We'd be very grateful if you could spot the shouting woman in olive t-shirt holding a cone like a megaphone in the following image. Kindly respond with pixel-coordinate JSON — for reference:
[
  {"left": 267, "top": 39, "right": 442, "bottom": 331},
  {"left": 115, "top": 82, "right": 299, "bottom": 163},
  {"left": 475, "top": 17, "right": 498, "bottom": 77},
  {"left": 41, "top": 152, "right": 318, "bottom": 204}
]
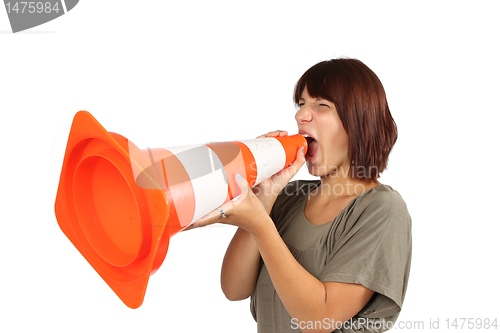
[{"left": 191, "top": 59, "right": 411, "bottom": 332}]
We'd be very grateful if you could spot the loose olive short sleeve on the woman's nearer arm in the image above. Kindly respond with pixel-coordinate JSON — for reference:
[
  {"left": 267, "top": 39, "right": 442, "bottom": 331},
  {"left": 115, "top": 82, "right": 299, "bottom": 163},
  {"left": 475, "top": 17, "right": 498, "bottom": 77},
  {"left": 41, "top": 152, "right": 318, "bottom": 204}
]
[{"left": 320, "top": 186, "right": 411, "bottom": 317}]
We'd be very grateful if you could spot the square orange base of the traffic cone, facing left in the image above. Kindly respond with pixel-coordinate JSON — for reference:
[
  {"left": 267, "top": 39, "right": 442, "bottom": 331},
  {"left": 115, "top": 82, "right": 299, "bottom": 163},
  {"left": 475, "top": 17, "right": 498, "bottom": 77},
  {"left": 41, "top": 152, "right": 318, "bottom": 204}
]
[{"left": 55, "top": 111, "right": 169, "bottom": 308}]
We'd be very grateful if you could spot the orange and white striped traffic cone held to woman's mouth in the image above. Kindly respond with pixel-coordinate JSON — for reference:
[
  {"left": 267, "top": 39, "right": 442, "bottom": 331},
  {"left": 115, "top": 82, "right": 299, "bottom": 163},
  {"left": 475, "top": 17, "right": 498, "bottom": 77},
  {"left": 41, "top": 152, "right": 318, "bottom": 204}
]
[{"left": 55, "top": 111, "right": 307, "bottom": 308}]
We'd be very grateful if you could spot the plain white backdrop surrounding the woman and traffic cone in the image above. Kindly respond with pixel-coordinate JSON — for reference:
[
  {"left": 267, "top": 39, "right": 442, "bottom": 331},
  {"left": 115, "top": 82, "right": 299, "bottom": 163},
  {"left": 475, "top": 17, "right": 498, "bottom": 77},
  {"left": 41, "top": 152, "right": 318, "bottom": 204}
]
[{"left": 0, "top": 0, "right": 500, "bottom": 332}]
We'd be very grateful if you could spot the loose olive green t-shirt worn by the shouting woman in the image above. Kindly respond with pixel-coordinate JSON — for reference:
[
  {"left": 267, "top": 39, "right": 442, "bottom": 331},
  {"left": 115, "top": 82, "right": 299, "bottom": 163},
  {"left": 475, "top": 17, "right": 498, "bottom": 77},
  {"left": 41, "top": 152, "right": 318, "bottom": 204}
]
[{"left": 250, "top": 181, "right": 412, "bottom": 333}]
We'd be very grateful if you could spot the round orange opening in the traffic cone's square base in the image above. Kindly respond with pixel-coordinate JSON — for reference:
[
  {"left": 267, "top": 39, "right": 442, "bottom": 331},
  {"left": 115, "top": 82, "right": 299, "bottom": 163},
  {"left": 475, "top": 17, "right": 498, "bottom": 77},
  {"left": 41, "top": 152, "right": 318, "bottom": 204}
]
[{"left": 72, "top": 155, "right": 143, "bottom": 267}]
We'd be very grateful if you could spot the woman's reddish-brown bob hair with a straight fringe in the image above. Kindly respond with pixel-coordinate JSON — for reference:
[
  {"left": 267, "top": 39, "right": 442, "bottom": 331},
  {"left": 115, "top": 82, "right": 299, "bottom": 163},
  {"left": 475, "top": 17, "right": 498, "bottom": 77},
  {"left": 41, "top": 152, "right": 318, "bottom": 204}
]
[{"left": 294, "top": 58, "right": 398, "bottom": 180}]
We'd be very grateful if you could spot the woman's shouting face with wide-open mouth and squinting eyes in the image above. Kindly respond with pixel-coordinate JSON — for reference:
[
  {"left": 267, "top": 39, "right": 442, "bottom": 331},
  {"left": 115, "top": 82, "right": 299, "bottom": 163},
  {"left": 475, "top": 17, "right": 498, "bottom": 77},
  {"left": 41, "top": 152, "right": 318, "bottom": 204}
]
[{"left": 295, "top": 88, "right": 349, "bottom": 177}]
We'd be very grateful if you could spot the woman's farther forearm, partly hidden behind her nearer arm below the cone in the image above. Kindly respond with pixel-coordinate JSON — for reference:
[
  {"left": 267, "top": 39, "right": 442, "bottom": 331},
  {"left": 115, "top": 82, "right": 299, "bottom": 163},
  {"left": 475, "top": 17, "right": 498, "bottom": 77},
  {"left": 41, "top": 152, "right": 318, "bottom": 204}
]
[{"left": 221, "top": 228, "right": 260, "bottom": 300}]
